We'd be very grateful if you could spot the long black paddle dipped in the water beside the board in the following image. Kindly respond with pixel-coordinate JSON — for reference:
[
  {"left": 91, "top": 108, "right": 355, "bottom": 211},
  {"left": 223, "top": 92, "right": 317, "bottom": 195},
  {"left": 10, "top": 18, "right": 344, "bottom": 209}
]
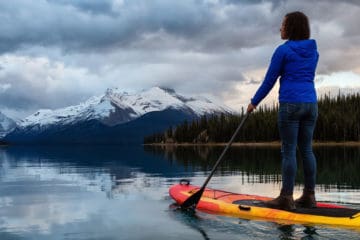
[{"left": 180, "top": 112, "right": 250, "bottom": 209}]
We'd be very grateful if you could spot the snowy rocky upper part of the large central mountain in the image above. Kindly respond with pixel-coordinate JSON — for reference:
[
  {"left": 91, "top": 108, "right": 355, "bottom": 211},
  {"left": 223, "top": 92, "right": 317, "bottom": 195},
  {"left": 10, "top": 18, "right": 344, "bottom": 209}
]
[{"left": 20, "top": 87, "right": 232, "bottom": 127}]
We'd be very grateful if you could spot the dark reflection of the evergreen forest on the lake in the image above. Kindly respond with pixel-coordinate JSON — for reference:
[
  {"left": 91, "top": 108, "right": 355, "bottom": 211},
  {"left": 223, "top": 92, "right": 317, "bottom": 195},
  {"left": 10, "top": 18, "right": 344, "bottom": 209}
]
[{"left": 145, "top": 146, "right": 360, "bottom": 190}]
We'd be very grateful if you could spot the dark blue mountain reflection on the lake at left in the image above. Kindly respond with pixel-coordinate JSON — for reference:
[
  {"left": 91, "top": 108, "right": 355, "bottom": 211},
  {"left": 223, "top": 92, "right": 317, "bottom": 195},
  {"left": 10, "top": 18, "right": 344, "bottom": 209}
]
[{"left": 0, "top": 146, "right": 191, "bottom": 179}]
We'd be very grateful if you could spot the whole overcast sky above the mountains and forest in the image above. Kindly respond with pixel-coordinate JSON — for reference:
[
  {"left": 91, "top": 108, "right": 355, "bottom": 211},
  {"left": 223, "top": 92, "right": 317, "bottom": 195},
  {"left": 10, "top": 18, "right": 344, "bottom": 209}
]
[{"left": 0, "top": 0, "right": 360, "bottom": 118}]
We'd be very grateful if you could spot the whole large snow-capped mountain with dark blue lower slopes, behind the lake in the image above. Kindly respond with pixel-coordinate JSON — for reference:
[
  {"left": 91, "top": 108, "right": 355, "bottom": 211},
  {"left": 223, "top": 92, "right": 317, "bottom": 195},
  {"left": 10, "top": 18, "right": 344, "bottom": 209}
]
[{"left": 4, "top": 87, "right": 233, "bottom": 143}]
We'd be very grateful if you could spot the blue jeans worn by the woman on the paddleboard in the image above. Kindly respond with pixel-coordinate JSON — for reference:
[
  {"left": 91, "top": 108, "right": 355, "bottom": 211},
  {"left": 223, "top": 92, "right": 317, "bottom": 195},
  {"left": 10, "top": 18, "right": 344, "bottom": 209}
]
[{"left": 278, "top": 103, "right": 318, "bottom": 195}]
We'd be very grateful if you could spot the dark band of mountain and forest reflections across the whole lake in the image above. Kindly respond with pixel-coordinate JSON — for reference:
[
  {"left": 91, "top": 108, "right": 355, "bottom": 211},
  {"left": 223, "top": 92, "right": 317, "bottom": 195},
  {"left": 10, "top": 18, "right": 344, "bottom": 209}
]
[{"left": 0, "top": 146, "right": 360, "bottom": 190}]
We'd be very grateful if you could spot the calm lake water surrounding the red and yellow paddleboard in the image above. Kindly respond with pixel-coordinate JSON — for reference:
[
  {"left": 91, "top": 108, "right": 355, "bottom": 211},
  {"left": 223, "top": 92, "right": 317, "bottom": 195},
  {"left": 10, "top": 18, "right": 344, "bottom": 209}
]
[{"left": 0, "top": 146, "right": 360, "bottom": 240}]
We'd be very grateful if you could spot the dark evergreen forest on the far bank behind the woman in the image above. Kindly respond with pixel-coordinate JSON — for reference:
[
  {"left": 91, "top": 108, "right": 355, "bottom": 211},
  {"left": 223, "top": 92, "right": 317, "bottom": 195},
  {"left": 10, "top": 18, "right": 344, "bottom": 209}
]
[{"left": 144, "top": 93, "right": 360, "bottom": 143}]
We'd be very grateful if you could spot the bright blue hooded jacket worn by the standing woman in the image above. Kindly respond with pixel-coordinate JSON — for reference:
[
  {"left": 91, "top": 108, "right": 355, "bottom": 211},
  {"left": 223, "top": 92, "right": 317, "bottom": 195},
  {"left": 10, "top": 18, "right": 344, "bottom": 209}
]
[{"left": 251, "top": 39, "right": 319, "bottom": 106}]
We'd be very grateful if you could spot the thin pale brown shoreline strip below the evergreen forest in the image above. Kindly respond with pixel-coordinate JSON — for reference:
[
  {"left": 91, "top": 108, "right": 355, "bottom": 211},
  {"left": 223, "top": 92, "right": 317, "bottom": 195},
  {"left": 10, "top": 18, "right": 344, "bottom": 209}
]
[{"left": 143, "top": 141, "right": 360, "bottom": 147}]
